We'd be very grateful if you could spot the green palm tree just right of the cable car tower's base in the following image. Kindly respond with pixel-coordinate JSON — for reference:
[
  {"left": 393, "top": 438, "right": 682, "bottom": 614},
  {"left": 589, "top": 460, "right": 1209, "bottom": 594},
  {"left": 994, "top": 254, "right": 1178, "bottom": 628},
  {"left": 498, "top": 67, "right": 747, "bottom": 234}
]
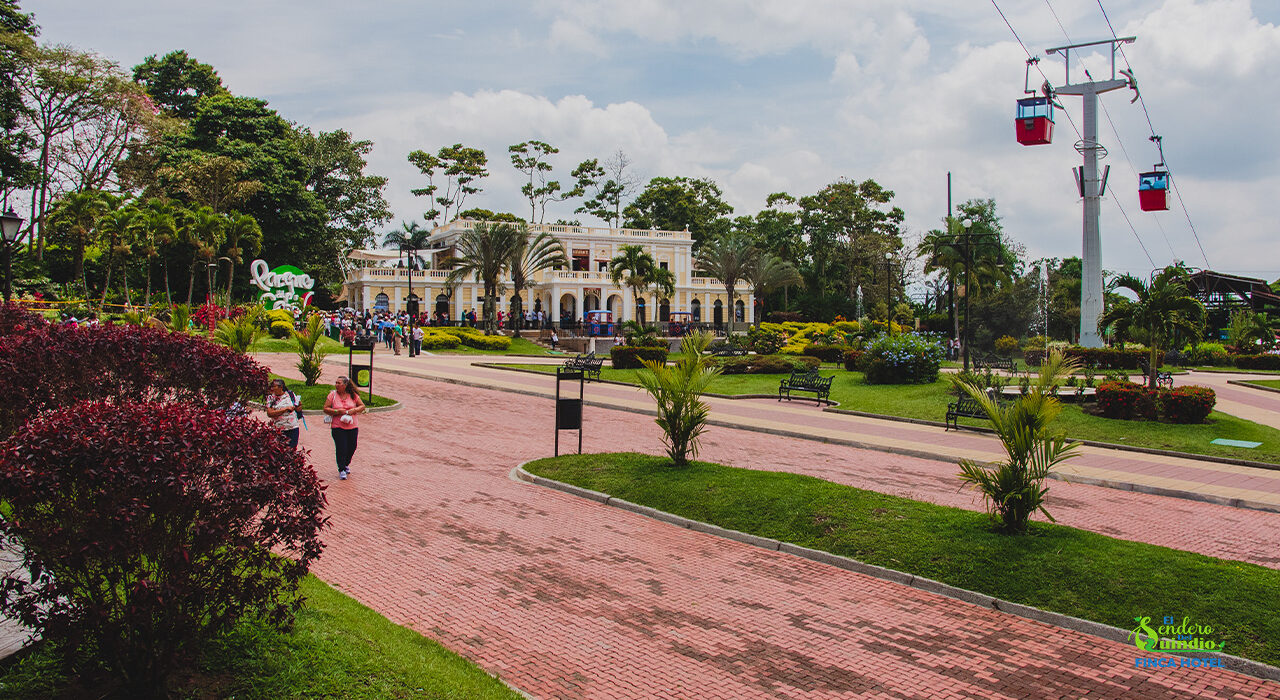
[{"left": 1098, "top": 265, "right": 1204, "bottom": 389}]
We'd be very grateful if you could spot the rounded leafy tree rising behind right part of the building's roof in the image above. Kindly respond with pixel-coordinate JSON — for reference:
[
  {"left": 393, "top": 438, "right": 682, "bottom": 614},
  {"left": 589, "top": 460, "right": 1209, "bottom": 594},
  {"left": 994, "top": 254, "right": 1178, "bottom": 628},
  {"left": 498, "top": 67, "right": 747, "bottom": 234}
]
[{"left": 622, "top": 178, "right": 733, "bottom": 244}]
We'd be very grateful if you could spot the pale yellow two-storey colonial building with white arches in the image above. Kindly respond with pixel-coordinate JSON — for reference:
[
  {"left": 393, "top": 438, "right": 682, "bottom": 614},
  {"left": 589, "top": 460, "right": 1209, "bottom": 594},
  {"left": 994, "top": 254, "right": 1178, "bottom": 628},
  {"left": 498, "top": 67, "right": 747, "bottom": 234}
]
[{"left": 344, "top": 219, "right": 755, "bottom": 325}]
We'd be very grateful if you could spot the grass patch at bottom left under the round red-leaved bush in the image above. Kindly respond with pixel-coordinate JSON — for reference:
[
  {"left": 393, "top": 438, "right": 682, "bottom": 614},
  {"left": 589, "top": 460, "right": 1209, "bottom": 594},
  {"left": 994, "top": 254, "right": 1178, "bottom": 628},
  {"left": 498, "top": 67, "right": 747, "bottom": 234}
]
[{"left": 0, "top": 577, "right": 520, "bottom": 700}]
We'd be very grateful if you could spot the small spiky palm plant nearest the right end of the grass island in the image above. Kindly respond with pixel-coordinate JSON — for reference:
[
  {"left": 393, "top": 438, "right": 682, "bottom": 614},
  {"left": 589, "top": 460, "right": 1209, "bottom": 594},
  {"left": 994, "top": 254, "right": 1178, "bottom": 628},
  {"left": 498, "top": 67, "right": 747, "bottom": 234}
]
[{"left": 954, "top": 351, "right": 1079, "bottom": 534}]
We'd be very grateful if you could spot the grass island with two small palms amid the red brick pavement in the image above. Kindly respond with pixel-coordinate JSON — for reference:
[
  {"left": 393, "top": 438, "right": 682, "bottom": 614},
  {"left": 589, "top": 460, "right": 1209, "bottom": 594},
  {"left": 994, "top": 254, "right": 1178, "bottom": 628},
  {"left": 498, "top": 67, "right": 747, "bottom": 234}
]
[{"left": 525, "top": 453, "right": 1280, "bottom": 664}]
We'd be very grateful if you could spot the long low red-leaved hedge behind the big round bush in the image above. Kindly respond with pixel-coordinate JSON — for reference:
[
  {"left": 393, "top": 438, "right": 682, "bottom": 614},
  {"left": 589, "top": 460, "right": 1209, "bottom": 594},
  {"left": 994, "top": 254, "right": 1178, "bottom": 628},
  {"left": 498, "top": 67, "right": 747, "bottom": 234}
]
[{"left": 0, "top": 324, "right": 268, "bottom": 438}]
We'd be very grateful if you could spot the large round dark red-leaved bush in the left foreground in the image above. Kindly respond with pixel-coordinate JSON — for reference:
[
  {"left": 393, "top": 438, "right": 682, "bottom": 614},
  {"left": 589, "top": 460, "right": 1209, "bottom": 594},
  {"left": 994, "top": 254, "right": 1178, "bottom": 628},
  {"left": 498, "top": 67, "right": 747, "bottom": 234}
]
[{"left": 0, "top": 402, "right": 326, "bottom": 696}]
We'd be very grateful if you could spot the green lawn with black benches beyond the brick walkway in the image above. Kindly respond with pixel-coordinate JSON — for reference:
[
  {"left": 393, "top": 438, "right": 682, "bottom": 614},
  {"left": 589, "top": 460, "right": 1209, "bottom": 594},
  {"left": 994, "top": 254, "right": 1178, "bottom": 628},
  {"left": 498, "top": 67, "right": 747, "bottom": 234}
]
[{"left": 501, "top": 365, "right": 1280, "bottom": 463}]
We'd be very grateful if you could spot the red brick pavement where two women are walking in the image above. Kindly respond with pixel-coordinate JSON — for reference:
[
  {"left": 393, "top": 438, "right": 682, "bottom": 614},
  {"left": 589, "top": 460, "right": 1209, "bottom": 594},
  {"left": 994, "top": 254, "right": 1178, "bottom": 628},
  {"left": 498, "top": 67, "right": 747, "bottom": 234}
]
[{"left": 275, "top": 363, "right": 1280, "bottom": 699}]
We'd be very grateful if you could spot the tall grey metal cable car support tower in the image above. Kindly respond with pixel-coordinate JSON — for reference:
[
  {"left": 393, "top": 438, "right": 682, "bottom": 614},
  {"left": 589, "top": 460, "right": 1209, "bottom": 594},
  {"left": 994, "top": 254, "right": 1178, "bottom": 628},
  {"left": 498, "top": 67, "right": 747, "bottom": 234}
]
[{"left": 1044, "top": 36, "right": 1138, "bottom": 348}]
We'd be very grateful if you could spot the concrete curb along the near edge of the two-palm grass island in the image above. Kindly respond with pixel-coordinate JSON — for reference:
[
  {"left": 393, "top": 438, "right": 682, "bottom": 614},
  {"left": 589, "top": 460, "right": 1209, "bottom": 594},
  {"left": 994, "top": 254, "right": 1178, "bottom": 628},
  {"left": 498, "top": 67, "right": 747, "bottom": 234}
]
[{"left": 511, "top": 462, "right": 1280, "bottom": 682}]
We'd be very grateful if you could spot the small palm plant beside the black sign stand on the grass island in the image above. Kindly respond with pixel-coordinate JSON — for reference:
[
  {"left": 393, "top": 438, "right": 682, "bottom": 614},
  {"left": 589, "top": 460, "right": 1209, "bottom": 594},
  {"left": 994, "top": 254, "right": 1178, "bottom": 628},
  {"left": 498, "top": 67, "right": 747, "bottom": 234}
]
[{"left": 636, "top": 331, "right": 721, "bottom": 467}]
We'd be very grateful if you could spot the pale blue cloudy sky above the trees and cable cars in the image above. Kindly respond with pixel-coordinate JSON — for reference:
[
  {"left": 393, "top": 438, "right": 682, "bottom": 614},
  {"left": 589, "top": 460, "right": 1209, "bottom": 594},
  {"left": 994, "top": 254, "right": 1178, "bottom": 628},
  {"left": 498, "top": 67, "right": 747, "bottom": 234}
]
[{"left": 22, "top": 0, "right": 1280, "bottom": 280}]
